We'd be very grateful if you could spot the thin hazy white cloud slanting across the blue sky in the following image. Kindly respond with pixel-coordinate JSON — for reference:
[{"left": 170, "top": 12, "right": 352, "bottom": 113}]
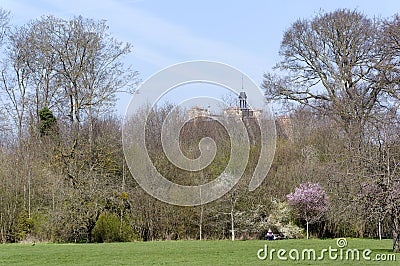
[{"left": 18, "top": 0, "right": 265, "bottom": 80}]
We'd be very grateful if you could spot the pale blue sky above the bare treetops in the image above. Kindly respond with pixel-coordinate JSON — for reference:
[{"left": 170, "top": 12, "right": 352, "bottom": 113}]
[{"left": 0, "top": 0, "right": 400, "bottom": 114}]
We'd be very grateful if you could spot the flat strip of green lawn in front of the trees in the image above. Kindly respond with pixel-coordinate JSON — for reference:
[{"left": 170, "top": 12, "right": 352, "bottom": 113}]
[{"left": 0, "top": 239, "right": 400, "bottom": 265}]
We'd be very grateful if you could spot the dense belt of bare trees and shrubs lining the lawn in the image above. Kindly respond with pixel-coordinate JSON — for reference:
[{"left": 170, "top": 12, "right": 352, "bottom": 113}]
[{"left": 0, "top": 10, "right": 400, "bottom": 250}]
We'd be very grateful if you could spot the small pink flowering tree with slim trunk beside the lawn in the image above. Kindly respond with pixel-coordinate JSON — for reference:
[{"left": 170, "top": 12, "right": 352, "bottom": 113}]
[{"left": 286, "top": 183, "right": 328, "bottom": 239}]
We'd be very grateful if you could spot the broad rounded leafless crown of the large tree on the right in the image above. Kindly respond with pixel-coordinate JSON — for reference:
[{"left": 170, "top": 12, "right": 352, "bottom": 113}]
[{"left": 263, "top": 9, "right": 385, "bottom": 140}]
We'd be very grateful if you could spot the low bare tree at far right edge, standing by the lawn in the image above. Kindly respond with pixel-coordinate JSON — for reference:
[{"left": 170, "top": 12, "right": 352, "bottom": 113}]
[{"left": 359, "top": 112, "right": 400, "bottom": 252}]
